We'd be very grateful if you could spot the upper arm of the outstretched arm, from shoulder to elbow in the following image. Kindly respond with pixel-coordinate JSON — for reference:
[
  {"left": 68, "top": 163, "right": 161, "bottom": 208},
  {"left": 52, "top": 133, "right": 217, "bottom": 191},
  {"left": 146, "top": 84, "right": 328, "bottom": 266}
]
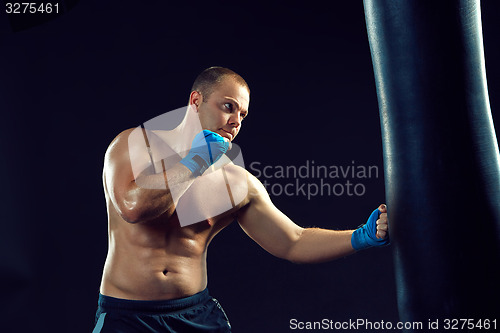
[{"left": 238, "top": 176, "right": 304, "bottom": 259}]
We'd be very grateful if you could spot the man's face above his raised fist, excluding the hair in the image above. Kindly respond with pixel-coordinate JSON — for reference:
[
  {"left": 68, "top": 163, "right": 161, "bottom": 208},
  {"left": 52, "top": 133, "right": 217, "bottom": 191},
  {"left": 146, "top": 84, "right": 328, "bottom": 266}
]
[{"left": 198, "top": 78, "right": 250, "bottom": 141}]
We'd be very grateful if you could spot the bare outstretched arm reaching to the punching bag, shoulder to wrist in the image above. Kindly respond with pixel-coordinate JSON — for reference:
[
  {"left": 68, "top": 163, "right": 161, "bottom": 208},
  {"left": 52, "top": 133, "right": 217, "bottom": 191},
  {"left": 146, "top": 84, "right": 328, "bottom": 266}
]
[{"left": 238, "top": 175, "right": 355, "bottom": 263}]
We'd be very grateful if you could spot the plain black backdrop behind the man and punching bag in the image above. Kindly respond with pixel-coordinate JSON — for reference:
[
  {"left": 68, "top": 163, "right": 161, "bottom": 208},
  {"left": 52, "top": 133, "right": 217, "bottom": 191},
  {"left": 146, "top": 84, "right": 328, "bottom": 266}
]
[{"left": 0, "top": 0, "right": 500, "bottom": 333}]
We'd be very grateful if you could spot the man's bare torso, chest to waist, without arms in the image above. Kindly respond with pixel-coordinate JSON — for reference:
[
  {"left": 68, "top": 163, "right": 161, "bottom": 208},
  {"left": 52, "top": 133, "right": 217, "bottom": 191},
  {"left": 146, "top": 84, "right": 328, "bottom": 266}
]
[{"left": 100, "top": 130, "right": 248, "bottom": 300}]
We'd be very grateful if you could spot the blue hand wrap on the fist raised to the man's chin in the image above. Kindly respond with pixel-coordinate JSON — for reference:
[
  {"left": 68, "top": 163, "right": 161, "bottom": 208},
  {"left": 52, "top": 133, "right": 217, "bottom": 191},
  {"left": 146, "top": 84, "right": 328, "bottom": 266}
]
[{"left": 180, "top": 130, "right": 229, "bottom": 176}]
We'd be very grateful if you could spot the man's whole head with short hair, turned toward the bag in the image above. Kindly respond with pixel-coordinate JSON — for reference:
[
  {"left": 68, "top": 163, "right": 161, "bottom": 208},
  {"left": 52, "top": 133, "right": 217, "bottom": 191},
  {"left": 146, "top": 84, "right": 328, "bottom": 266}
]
[{"left": 189, "top": 67, "right": 250, "bottom": 141}]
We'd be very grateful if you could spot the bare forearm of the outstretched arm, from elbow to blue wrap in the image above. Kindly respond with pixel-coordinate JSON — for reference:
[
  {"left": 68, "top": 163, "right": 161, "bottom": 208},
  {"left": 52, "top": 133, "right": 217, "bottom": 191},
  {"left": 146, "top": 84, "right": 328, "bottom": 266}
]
[{"left": 287, "top": 228, "right": 356, "bottom": 263}]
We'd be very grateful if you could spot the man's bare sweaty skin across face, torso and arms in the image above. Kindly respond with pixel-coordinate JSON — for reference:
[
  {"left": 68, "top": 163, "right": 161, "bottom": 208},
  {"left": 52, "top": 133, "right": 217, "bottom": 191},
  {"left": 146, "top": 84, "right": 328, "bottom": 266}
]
[{"left": 100, "top": 78, "right": 387, "bottom": 300}]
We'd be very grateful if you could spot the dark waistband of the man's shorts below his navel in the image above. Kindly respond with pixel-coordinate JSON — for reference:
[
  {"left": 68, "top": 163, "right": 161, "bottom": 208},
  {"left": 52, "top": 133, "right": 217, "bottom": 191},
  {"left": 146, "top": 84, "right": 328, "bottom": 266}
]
[{"left": 98, "top": 289, "right": 211, "bottom": 313}]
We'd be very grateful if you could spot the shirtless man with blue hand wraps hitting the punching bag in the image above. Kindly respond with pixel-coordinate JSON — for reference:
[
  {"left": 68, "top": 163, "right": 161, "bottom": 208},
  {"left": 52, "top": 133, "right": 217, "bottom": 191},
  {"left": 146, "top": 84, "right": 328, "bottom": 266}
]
[{"left": 94, "top": 67, "right": 388, "bottom": 333}]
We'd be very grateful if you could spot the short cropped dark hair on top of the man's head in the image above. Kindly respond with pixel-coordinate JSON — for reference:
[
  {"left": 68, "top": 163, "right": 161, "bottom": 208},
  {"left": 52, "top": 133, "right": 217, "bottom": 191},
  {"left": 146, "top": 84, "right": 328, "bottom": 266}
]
[{"left": 191, "top": 66, "right": 250, "bottom": 99}]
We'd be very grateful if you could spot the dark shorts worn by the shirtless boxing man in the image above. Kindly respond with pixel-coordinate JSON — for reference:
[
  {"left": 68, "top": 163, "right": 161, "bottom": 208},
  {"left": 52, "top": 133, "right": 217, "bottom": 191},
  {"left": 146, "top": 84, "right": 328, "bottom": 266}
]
[{"left": 92, "top": 289, "right": 231, "bottom": 333}]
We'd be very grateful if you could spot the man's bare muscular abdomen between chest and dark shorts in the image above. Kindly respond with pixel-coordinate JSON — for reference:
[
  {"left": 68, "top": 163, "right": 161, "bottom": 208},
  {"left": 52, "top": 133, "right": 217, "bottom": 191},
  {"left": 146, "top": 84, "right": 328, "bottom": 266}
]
[{"left": 100, "top": 202, "right": 232, "bottom": 300}]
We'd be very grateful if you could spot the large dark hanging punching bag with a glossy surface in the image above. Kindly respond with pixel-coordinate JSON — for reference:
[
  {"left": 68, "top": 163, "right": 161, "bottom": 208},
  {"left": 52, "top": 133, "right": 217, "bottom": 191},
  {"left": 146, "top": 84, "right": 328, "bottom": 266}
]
[{"left": 364, "top": 0, "right": 500, "bottom": 326}]
